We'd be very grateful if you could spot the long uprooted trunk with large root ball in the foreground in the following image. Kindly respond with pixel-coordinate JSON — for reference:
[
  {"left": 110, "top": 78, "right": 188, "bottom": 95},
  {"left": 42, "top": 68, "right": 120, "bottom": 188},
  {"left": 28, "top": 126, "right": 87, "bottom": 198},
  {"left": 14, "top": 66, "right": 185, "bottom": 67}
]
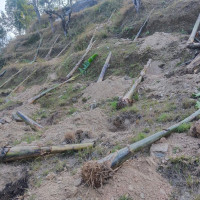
[{"left": 82, "top": 109, "right": 200, "bottom": 187}]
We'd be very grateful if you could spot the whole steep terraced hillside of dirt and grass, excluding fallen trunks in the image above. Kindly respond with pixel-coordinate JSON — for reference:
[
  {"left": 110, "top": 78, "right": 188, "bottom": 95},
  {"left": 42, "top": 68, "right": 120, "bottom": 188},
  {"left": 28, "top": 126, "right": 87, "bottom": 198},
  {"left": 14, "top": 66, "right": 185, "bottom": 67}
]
[{"left": 0, "top": 0, "right": 200, "bottom": 200}]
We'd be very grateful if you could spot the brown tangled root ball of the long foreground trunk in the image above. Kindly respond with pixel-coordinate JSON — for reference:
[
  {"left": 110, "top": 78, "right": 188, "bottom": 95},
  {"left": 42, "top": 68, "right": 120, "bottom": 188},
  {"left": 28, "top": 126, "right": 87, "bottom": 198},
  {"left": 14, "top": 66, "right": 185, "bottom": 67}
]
[{"left": 81, "top": 161, "right": 114, "bottom": 188}]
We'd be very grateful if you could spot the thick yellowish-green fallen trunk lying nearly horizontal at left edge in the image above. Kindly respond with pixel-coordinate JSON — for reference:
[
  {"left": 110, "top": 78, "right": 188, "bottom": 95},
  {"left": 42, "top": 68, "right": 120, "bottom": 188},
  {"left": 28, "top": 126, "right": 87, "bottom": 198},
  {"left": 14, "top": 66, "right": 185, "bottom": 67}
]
[{"left": 0, "top": 143, "right": 94, "bottom": 162}]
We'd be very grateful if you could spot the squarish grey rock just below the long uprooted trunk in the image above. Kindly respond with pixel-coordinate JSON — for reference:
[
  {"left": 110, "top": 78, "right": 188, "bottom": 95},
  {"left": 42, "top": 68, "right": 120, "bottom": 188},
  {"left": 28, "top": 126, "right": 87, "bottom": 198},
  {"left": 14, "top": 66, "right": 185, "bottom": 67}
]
[{"left": 150, "top": 143, "right": 169, "bottom": 158}]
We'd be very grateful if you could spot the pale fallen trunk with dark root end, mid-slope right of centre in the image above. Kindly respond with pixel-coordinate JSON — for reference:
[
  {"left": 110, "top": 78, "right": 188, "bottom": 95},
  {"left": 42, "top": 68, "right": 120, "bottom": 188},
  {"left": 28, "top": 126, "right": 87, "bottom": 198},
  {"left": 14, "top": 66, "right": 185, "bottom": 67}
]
[{"left": 117, "top": 59, "right": 152, "bottom": 109}]
